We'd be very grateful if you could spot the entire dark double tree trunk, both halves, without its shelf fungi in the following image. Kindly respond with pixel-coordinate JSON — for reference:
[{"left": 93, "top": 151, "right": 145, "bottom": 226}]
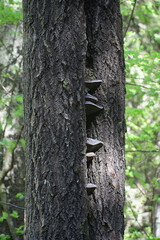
[{"left": 23, "top": 0, "right": 125, "bottom": 240}]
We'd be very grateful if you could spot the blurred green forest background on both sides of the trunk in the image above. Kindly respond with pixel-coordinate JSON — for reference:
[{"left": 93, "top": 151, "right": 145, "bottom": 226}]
[{"left": 0, "top": 0, "right": 160, "bottom": 240}]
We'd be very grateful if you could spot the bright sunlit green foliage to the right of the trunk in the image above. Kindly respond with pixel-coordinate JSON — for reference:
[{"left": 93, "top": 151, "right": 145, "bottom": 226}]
[{"left": 121, "top": 0, "right": 160, "bottom": 240}]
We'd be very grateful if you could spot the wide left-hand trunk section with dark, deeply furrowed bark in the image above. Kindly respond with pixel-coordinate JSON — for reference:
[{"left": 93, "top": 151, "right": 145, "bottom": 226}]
[{"left": 23, "top": 0, "right": 87, "bottom": 240}]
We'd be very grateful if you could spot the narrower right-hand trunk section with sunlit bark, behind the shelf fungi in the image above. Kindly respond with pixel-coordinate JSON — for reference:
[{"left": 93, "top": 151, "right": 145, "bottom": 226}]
[{"left": 85, "top": 0, "right": 125, "bottom": 240}]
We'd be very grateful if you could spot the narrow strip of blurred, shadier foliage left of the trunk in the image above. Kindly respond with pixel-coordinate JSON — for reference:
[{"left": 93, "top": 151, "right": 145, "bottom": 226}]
[{"left": 0, "top": 0, "right": 25, "bottom": 240}]
